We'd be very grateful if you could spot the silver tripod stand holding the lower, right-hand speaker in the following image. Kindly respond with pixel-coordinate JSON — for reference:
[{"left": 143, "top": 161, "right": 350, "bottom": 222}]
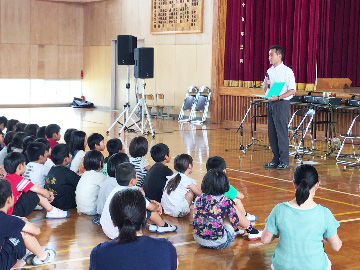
[{"left": 119, "top": 79, "right": 155, "bottom": 138}]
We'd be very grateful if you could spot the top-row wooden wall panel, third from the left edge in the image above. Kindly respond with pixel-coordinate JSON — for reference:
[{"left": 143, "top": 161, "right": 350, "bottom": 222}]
[{"left": 58, "top": 3, "right": 84, "bottom": 46}]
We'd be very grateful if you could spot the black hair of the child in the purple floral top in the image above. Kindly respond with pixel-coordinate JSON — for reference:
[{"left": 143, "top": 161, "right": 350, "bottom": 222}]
[{"left": 201, "top": 170, "right": 230, "bottom": 195}]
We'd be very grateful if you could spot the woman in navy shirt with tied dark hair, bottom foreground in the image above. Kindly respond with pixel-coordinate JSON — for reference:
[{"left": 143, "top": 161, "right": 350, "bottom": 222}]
[{"left": 90, "top": 189, "right": 177, "bottom": 270}]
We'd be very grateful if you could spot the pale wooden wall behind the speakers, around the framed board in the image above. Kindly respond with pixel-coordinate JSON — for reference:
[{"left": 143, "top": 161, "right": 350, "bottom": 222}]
[{"left": 84, "top": 0, "right": 213, "bottom": 113}]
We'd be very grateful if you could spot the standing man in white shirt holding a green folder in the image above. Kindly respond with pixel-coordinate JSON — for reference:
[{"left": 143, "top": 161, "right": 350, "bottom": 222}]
[{"left": 263, "top": 45, "right": 296, "bottom": 170}]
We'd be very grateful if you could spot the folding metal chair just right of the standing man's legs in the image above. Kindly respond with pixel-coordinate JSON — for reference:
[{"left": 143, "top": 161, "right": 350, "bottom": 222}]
[{"left": 288, "top": 108, "right": 315, "bottom": 163}]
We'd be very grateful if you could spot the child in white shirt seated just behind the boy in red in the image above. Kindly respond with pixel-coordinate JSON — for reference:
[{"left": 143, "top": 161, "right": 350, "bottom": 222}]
[{"left": 24, "top": 142, "right": 50, "bottom": 188}]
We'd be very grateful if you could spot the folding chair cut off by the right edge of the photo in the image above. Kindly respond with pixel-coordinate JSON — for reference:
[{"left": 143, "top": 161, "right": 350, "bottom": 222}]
[{"left": 336, "top": 115, "right": 360, "bottom": 169}]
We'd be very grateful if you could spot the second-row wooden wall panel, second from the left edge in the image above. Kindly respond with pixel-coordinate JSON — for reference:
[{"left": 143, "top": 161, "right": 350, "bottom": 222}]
[{"left": 30, "top": 45, "right": 59, "bottom": 79}]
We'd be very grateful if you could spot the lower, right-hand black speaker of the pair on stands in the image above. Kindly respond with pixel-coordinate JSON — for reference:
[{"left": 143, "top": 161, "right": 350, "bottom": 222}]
[{"left": 134, "top": 48, "right": 154, "bottom": 79}]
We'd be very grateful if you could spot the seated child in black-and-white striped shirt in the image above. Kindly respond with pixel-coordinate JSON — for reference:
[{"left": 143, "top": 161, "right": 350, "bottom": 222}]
[{"left": 129, "top": 137, "right": 151, "bottom": 187}]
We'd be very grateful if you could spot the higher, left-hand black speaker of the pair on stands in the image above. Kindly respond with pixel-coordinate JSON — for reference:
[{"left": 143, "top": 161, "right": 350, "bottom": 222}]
[{"left": 117, "top": 35, "right": 137, "bottom": 65}]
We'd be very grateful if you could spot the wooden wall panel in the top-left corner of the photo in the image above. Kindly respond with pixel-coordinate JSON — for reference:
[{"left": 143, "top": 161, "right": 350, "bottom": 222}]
[{"left": 0, "top": 0, "right": 30, "bottom": 44}]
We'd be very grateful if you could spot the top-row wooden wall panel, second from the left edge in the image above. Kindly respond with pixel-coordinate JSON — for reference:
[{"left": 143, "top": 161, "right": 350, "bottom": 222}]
[{"left": 31, "top": 0, "right": 59, "bottom": 45}]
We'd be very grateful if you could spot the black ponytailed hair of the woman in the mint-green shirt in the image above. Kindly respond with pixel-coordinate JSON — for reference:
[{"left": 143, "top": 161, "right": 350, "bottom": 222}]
[{"left": 293, "top": 165, "right": 319, "bottom": 206}]
